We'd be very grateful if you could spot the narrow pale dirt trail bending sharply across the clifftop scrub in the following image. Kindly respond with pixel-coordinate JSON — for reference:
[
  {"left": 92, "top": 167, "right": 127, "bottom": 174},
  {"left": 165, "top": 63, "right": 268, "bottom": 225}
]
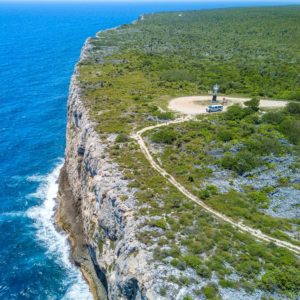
[{"left": 132, "top": 104, "right": 300, "bottom": 254}]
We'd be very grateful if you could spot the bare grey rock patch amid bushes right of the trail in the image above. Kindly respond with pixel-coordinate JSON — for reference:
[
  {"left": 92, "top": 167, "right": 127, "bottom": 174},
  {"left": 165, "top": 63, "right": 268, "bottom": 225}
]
[{"left": 204, "top": 155, "right": 300, "bottom": 219}]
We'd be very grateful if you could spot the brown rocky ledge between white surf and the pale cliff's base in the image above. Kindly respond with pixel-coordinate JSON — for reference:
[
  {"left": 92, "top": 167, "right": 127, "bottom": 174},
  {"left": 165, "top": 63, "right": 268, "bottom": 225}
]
[{"left": 56, "top": 165, "right": 107, "bottom": 300}]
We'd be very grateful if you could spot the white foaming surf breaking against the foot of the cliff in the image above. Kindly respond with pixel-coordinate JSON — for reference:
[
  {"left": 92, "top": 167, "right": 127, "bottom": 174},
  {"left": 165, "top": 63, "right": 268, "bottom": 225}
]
[{"left": 26, "top": 160, "right": 93, "bottom": 300}]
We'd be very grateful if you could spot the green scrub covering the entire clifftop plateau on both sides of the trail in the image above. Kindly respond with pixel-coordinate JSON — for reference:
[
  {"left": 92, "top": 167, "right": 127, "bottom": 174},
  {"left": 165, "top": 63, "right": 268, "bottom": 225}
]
[{"left": 78, "top": 6, "right": 300, "bottom": 299}]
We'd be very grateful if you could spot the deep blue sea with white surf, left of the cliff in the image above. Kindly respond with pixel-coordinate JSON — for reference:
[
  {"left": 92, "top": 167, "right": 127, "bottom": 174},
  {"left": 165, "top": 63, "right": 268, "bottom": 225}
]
[{"left": 0, "top": 3, "right": 296, "bottom": 300}]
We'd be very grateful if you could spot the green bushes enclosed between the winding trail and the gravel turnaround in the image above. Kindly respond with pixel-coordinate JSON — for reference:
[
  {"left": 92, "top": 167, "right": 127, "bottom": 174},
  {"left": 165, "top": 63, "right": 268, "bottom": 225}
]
[{"left": 148, "top": 104, "right": 300, "bottom": 244}]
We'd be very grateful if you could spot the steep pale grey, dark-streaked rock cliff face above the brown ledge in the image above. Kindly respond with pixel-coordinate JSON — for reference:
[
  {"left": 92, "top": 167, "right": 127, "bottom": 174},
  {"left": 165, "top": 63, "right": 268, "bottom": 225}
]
[{"left": 60, "top": 45, "right": 157, "bottom": 299}]
